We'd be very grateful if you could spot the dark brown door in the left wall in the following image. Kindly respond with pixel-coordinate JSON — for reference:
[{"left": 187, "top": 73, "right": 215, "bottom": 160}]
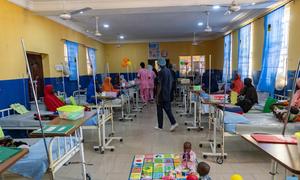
[{"left": 27, "top": 53, "right": 44, "bottom": 101}]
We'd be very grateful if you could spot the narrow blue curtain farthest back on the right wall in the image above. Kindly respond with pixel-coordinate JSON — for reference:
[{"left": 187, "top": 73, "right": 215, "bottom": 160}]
[{"left": 222, "top": 34, "right": 231, "bottom": 82}]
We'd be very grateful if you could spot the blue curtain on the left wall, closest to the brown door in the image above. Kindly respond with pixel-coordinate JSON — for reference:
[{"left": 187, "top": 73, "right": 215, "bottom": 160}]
[{"left": 66, "top": 41, "right": 79, "bottom": 81}]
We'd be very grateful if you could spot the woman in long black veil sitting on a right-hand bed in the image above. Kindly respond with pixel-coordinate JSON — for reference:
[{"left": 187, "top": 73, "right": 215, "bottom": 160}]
[{"left": 236, "top": 78, "right": 258, "bottom": 113}]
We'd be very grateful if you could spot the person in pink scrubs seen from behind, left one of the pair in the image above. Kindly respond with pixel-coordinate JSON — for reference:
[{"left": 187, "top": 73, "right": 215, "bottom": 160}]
[{"left": 137, "top": 62, "right": 150, "bottom": 104}]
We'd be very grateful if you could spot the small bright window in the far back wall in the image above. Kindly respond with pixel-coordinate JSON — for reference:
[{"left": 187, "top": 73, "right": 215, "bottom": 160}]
[{"left": 179, "top": 56, "right": 205, "bottom": 77}]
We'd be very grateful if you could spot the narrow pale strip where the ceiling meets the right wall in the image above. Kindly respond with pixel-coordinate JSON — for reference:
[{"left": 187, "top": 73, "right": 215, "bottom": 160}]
[{"left": 224, "top": 0, "right": 295, "bottom": 36}]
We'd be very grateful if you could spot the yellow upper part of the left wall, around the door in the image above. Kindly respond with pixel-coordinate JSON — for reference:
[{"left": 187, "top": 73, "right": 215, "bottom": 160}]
[{"left": 0, "top": 0, "right": 104, "bottom": 80}]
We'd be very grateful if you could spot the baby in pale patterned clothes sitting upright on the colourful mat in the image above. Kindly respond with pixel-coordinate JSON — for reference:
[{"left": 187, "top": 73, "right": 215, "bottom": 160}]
[{"left": 175, "top": 142, "right": 197, "bottom": 173}]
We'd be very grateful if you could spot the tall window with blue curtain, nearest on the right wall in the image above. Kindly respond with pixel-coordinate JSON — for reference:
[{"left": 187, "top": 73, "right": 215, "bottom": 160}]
[{"left": 258, "top": 6, "right": 290, "bottom": 95}]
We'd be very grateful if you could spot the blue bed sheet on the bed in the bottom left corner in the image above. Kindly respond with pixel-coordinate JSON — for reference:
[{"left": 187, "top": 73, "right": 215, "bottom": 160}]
[{"left": 9, "top": 138, "right": 75, "bottom": 180}]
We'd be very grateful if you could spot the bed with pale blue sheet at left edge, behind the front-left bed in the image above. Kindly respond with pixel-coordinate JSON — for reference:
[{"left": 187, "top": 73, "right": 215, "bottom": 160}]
[{"left": 0, "top": 108, "right": 53, "bottom": 130}]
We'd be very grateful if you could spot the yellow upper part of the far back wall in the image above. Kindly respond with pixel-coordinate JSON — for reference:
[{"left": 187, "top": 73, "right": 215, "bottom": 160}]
[{"left": 104, "top": 38, "right": 224, "bottom": 73}]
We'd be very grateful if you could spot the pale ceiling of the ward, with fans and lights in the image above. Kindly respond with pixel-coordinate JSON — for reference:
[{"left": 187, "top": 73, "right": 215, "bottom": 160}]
[{"left": 10, "top": 0, "right": 283, "bottom": 43}]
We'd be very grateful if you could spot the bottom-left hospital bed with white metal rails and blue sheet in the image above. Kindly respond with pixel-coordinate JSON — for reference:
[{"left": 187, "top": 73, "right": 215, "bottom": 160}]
[{"left": 4, "top": 134, "right": 86, "bottom": 180}]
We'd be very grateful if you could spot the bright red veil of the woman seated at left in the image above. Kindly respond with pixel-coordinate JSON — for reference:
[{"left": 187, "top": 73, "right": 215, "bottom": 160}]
[{"left": 44, "top": 85, "right": 65, "bottom": 112}]
